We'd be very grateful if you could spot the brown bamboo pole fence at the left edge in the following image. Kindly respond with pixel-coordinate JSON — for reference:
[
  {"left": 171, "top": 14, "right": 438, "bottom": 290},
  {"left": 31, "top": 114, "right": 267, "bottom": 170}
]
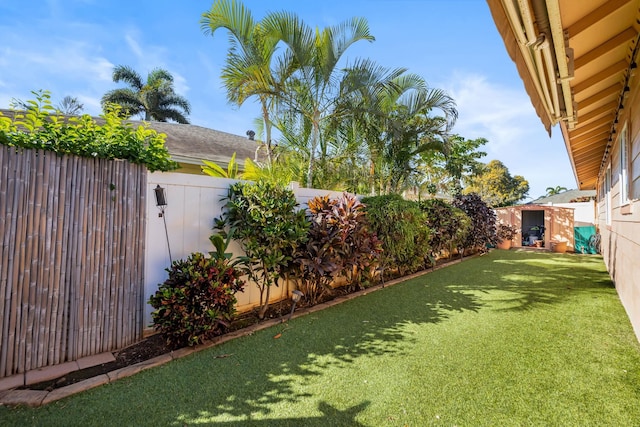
[{"left": 0, "top": 146, "right": 147, "bottom": 377}]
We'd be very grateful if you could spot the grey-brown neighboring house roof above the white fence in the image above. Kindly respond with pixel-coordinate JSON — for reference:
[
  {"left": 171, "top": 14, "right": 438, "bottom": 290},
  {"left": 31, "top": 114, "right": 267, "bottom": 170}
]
[{"left": 0, "top": 109, "right": 263, "bottom": 168}]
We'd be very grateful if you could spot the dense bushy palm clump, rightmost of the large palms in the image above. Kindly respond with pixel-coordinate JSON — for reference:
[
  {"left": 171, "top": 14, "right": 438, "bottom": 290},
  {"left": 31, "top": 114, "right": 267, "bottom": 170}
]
[{"left": 338, "top": 61, "right": 457, "bottom": 194}]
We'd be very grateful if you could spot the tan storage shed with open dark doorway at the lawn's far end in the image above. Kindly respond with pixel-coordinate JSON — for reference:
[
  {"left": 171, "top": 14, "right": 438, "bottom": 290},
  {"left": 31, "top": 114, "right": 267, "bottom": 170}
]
[{"left": 495, "top": 205, "right": 575, "bottom": 252}]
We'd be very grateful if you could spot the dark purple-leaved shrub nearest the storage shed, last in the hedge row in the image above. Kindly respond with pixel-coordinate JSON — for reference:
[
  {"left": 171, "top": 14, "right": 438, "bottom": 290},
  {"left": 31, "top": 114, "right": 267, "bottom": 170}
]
[{"left": 453, "top": 193, "right": 496, "bottom": 252}]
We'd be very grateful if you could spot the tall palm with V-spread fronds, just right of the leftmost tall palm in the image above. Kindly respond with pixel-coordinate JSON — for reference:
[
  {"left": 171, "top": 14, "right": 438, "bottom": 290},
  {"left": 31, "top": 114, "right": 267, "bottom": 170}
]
[{"left": 262, "top": 12, "right": 374, "bottom": 187}]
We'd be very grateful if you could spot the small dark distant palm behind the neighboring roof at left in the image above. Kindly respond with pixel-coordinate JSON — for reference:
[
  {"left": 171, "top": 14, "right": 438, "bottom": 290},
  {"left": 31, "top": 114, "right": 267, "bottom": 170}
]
[{"left": 102, "top": 65, "right": 191, "bottom": 123}]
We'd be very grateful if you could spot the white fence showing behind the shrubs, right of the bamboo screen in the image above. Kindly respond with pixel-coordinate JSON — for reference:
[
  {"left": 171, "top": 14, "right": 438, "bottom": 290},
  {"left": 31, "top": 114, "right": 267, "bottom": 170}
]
[{"left": 144, "top": 172, "right": 342, "bottom": 327}]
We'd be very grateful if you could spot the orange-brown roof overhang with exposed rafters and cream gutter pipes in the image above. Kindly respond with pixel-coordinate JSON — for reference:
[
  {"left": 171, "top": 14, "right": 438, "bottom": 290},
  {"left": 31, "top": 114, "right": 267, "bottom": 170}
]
[{"left": 487, "top": 0, "right": 640, "bottom": 190}]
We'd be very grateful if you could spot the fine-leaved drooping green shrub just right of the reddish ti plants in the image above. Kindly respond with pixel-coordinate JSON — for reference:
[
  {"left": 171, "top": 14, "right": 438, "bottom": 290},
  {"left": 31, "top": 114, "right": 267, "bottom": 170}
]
[{"left": 362, "top": 195, "right": 431, "bottom": 274}]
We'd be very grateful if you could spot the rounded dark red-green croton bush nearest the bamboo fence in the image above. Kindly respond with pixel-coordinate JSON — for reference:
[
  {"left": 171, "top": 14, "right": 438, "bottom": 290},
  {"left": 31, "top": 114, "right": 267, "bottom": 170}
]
[{"left": 149, "top": 252, "right": 244, "bottom": 348}]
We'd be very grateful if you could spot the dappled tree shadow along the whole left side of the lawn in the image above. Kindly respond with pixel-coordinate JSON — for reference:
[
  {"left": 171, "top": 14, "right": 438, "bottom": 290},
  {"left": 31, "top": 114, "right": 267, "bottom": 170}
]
[{"left": 7, "top": 251, "right": 611, "bottom": 425}]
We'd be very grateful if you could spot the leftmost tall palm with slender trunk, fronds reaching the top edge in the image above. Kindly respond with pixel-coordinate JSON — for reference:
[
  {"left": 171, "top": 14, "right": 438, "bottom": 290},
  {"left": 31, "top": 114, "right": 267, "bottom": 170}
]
[{"left": 200, "top": 0, "right": 286, "bottom": 165}]
